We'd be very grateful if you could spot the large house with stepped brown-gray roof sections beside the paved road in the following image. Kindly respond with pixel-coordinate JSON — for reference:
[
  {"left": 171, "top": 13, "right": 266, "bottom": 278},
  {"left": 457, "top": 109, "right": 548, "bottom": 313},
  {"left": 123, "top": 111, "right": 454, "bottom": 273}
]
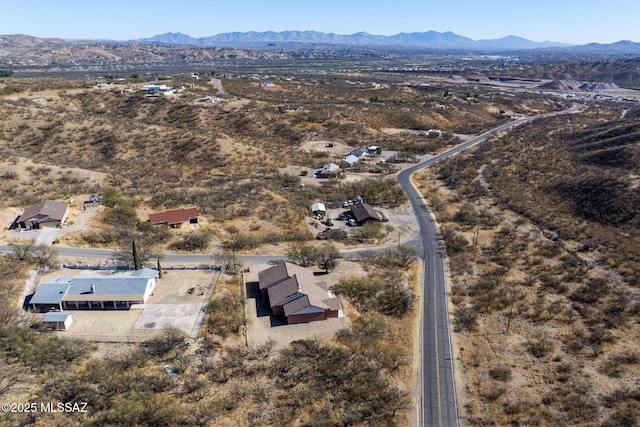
[{"left": 258, "top": 262, "right": 340, "bottom": 324}]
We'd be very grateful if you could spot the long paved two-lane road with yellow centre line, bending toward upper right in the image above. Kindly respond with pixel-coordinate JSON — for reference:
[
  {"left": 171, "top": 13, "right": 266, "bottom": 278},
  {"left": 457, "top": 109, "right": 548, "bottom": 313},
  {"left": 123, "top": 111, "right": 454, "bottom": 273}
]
[{"left": 398, "top": 105, "right": 583, "bottom": 427}]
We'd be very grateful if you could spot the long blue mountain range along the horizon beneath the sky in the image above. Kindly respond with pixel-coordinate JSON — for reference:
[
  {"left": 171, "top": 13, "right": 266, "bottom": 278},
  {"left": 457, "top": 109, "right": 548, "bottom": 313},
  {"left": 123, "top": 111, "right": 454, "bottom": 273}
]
[{"left": 135, "top": 31, "right": 571, "bottom": 50}]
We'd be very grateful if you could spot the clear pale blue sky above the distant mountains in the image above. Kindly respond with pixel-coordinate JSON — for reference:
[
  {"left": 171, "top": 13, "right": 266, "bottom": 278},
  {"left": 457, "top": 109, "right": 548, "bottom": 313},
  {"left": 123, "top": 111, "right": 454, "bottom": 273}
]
[{"left": 0, "top": 0, "right": 640, "bottom": 44}]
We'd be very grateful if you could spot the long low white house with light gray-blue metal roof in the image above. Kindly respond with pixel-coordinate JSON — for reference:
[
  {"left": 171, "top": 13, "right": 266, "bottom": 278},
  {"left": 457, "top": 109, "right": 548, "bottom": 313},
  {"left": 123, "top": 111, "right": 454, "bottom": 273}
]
[{"left": 29, "top": 268, "right": 158, "bottom": 312}]
